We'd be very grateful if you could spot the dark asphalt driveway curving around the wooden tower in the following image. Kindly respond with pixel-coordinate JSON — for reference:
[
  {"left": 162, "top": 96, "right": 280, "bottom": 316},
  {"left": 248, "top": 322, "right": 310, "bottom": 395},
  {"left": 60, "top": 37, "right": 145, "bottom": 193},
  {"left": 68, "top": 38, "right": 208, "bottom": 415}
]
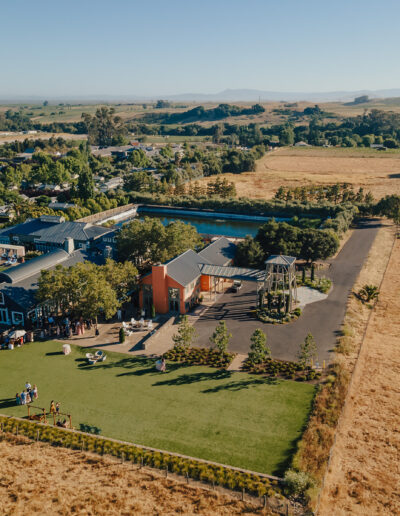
[{"left": 195, "top": 221, "right": 379, "bottom": 362}]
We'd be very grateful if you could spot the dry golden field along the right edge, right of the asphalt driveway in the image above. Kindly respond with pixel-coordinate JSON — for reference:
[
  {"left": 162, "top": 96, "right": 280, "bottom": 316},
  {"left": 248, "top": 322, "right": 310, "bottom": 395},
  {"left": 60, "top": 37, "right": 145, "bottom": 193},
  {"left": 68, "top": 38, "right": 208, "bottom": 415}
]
[{"left": 319, "top": 236, "right": 400, "bottom": 516}]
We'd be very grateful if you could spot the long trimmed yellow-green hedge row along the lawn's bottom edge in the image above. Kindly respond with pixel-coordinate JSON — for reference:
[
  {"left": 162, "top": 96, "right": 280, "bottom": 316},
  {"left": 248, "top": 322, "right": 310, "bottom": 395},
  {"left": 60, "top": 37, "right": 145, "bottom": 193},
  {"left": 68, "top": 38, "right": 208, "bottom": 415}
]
[{"left": 0, "top": 416, "right": 282, "bottom": 498}]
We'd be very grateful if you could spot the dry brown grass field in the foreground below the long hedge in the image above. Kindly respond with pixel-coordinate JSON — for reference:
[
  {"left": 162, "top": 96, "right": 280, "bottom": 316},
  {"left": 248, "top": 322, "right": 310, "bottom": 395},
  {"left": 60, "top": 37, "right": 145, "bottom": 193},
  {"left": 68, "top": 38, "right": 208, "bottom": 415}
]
[{"left": 0, "top": 438, "right": 276, "bottom": 516}]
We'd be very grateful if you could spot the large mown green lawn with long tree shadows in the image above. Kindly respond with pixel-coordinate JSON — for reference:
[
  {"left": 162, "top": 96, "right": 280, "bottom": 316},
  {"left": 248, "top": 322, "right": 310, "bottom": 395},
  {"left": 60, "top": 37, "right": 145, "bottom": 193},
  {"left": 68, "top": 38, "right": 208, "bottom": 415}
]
[{"left": 0, "top": 342, "right": 314, "bottom": 474}]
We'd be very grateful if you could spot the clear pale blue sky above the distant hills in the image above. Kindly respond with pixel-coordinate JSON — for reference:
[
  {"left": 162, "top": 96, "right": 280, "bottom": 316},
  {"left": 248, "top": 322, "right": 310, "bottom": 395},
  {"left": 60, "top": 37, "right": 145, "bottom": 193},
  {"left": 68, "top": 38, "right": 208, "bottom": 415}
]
[{"left": 0, "top": 0, "right": 400, "bottom": 97}]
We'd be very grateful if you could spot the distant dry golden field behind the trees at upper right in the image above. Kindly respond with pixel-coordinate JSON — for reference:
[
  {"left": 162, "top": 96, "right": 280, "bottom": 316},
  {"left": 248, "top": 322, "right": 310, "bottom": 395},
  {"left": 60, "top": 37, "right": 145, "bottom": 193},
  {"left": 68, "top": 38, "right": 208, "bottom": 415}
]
[{"left": 195, "top": 147, "right": 400, "bottom": 199}]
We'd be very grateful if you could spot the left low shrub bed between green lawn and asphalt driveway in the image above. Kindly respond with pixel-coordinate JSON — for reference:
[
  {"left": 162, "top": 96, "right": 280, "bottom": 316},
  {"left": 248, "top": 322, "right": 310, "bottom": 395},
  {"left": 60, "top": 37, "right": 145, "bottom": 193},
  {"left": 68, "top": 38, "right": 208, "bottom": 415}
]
[{"left": 164, "top": 348, "right": 236, "bottom": 368}]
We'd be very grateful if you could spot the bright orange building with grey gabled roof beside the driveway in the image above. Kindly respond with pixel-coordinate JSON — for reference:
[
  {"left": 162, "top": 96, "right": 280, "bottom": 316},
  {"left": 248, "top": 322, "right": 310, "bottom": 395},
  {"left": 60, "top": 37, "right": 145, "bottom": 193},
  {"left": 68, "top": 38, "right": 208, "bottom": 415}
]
[{"left": 139, "top": 237, "right": 236, "bottom": 314}]
